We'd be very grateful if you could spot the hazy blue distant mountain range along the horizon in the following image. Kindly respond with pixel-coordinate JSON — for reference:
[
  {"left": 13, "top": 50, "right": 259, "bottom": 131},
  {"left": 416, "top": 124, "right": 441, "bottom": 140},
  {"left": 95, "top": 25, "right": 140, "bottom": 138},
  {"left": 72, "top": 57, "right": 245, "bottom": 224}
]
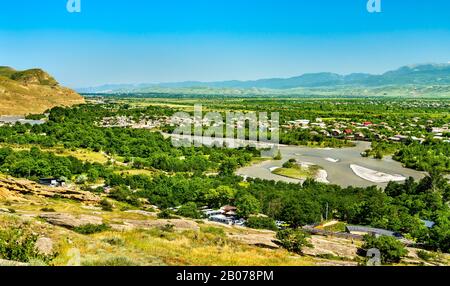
[{"left": 77, "top": 64, "right": 450, "bottom": 93}]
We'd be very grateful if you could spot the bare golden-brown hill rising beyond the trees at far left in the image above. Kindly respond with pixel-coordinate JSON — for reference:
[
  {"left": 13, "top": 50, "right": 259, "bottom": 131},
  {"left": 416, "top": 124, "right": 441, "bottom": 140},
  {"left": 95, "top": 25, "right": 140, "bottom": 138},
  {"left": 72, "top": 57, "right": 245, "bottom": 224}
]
[{"left": 0, "top": 67, "right": 84, "bottom": 115}]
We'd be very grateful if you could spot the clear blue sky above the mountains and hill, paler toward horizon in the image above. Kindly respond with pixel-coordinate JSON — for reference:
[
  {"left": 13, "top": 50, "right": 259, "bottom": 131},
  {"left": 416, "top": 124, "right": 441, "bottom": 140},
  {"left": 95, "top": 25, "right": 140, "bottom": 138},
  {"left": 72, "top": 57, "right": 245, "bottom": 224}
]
[{"left": 0, "top": 0, "right": 450, "bottom": 87}]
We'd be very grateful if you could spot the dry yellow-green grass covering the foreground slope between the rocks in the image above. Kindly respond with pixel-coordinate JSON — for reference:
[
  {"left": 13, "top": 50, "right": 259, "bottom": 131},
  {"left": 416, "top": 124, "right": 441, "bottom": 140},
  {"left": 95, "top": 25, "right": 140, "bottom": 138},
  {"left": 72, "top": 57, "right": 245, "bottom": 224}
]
[{"left": 0, "top": 185, "right": 321, "bottom": 265}]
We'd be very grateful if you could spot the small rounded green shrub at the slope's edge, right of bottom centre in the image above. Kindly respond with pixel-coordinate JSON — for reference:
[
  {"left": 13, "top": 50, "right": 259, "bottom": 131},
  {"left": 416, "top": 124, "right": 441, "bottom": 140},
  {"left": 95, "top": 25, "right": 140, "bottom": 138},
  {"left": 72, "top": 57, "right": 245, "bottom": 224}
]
[{"left": 276, "top": 229, "right": 313, "bottom": 255}]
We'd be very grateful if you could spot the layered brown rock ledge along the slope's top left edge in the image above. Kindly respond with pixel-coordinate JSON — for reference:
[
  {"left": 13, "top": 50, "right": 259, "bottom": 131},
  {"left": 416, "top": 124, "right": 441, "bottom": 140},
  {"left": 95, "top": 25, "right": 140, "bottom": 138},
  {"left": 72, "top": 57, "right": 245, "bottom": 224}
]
[{"left": 0, "top": 178, "right": 100, "bottom": 203}]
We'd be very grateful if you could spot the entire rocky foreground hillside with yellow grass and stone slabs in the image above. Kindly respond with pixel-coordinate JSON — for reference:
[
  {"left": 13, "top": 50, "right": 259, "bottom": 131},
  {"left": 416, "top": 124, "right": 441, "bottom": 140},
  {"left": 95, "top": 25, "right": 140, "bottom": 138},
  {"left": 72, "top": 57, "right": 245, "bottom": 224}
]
[{"left": 0, "top": 175, "right": 449, "bottom": 266}]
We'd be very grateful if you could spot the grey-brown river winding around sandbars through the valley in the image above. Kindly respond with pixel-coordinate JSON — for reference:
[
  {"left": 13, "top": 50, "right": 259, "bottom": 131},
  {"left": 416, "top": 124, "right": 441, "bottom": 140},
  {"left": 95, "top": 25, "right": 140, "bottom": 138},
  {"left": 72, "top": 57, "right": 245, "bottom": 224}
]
[{"left": 163, "top": 133, "right": 425, "bottom": 187}]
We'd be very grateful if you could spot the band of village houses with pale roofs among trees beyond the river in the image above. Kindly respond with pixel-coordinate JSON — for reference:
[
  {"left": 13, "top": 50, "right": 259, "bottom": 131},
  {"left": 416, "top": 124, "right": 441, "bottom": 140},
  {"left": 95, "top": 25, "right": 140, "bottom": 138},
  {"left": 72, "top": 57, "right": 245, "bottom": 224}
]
[{"left": 99, "top": 111, "right": 450, "bottom": 143}]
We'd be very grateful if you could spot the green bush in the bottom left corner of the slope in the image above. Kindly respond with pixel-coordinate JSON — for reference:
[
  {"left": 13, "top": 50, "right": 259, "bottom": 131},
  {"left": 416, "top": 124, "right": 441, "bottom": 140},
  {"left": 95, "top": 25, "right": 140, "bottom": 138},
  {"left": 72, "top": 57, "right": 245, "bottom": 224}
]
[{"left": 0, "top": 226, "right": 53, "bottom": 263}]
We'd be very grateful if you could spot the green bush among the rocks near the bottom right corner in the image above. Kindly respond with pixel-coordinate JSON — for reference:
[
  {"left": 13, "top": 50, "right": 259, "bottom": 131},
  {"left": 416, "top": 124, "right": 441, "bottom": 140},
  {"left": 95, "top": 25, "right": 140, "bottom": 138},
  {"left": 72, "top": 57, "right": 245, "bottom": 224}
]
[{"left": 362, "top": 235, "right": 408, "bottom": 264}]
